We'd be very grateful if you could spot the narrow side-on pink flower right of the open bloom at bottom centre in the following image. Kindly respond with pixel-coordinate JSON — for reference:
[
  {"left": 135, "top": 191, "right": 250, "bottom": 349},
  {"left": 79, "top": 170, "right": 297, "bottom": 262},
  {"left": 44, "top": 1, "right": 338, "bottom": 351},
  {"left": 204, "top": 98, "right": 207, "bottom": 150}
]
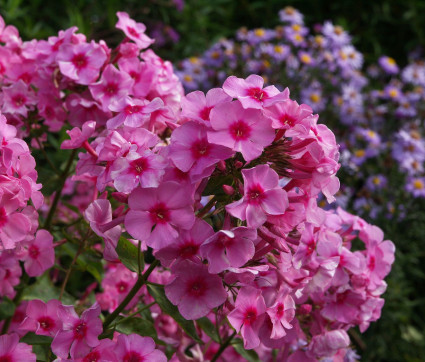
[{"left": 267, "top": 289, "right": 295, "bottom": 339}]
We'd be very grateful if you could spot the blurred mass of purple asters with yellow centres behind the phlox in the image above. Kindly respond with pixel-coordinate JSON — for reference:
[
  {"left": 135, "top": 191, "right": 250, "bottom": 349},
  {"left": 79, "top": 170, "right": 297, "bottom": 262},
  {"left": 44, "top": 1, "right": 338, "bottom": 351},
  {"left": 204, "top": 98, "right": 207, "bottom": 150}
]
[{"left": 177, "top": 7, "right": 425, "bottom": 220}]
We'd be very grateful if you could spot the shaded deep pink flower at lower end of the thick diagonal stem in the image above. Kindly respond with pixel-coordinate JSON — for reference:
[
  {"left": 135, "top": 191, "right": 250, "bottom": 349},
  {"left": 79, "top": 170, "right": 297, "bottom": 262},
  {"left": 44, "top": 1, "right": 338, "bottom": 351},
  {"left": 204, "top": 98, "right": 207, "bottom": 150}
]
[{"left": 52, "top": 303, "right": 103, "bottom": 359}]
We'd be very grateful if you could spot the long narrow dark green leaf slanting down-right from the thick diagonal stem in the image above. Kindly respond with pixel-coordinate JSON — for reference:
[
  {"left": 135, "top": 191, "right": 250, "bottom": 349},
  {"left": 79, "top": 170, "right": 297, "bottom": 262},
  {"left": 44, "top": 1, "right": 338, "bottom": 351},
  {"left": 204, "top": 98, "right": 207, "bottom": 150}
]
[{"left": 147, "top": 284, "right": 203, "bottom": 343}]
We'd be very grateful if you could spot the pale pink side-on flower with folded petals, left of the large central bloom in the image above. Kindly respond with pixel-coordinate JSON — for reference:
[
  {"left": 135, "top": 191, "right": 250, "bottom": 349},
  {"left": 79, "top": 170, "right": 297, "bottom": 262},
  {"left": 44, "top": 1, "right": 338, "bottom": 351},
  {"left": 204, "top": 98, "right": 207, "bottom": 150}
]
[{"left": 84, "top": 199, "right": 122, "bottom": 261}]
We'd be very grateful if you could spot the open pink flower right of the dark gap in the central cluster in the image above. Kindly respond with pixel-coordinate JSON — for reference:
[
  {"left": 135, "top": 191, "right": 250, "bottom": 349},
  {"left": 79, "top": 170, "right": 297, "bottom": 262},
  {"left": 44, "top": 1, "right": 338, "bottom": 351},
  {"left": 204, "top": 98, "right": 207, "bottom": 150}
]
[{"left": 226, "top": 165, "right": 289, "bottom": 228}]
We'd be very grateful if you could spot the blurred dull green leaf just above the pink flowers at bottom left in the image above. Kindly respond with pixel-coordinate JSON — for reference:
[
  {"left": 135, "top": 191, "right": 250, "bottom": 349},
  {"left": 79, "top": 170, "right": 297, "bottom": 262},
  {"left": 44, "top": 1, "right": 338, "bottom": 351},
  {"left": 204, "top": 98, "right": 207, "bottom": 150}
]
[{"left": 22, "top": 272, "right": 75, "bottom": 304}]
